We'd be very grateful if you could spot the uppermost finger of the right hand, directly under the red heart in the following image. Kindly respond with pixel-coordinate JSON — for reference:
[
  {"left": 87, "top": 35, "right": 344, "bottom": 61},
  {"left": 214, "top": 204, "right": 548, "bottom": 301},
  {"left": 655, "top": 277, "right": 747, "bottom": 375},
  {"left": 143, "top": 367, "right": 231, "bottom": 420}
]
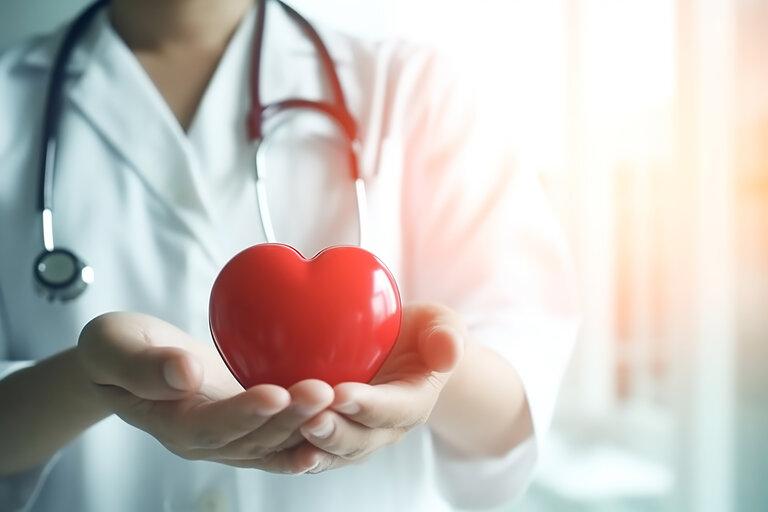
[{"left": 331, "top": 375, "right": 442, "bottom": 428}]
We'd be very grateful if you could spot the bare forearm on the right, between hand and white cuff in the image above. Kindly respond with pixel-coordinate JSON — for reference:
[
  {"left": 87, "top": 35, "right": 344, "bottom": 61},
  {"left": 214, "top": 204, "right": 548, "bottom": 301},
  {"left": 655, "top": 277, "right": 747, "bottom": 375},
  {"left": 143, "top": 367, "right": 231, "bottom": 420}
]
[{"left": 428, "top": 343, "right": 533, "bottom": 456}]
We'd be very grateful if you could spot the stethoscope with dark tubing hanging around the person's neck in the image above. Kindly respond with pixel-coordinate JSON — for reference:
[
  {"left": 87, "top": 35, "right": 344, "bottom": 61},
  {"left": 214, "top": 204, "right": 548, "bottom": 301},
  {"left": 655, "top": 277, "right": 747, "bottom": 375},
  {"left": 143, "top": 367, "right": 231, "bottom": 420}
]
[{"left": 34, "top": 0, "right": 367, "bottom": 301}]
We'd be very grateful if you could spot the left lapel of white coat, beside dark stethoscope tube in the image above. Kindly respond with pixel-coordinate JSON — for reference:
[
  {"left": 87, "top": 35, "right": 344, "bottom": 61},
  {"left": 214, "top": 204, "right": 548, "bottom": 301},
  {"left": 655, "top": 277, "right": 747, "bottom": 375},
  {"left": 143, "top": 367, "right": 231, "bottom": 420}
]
[{"left": 69, "top": 13, "right": 223, "bottom": 266}]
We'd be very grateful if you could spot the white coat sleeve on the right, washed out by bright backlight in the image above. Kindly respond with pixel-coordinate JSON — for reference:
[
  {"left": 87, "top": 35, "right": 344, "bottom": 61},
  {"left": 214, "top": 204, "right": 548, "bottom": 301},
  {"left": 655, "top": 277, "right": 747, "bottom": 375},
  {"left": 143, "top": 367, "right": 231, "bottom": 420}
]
[{"left": 403, "top": 52, "right": 578, "bottom": 507}]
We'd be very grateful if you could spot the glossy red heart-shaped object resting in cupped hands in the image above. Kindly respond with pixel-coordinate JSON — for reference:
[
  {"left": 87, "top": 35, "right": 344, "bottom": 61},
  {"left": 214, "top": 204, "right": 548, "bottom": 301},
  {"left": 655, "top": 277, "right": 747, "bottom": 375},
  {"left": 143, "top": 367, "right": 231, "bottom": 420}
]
[{"left": 209, "top": 244, "right": 402, "bottom": 389}]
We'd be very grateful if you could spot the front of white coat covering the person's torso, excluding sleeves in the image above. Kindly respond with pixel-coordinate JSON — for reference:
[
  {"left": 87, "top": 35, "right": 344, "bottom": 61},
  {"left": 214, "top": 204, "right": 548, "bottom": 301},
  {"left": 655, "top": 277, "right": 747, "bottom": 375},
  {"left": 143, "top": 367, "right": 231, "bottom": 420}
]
[{"left": 0, "top": 3, "right": 450, "bottom": 511}]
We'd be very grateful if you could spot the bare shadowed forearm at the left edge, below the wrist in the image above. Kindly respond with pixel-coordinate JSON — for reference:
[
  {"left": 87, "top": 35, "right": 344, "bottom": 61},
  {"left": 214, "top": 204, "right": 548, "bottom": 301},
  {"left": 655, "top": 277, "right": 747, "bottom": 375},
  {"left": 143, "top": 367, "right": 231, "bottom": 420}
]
[{"left": 0, "top": 349, "right": 109, "bottom": 474}]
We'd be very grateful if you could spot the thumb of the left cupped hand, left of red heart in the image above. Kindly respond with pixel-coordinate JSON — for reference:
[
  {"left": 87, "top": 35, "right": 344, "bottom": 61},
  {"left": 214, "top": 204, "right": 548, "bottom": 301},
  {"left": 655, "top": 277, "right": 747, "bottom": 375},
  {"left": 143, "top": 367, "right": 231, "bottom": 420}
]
[{"left": 78, "top": 319, "right": 203, "bottom": 400}]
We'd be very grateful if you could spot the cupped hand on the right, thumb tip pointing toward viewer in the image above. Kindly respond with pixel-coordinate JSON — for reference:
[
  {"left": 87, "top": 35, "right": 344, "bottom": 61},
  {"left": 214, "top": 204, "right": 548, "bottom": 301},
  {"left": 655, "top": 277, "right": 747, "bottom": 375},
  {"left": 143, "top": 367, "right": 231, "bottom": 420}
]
[{"left": 292, "top": 304, "right": 465, "bottom": 473}]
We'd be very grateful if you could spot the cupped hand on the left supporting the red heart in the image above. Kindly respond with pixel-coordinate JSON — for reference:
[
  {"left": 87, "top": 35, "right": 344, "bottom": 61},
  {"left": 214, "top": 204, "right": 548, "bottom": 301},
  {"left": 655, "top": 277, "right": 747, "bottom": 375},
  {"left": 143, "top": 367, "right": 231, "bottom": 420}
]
[{"left": 77, "top": 313, "right": 333, "bottom": 473}]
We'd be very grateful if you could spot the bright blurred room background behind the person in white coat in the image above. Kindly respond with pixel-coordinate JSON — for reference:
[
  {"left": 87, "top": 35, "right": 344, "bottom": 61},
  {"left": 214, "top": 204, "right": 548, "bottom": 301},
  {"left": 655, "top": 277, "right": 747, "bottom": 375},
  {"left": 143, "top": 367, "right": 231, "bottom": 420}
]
[{"left": 0, "top": 0, "right": 768, "bottom": 512}]
